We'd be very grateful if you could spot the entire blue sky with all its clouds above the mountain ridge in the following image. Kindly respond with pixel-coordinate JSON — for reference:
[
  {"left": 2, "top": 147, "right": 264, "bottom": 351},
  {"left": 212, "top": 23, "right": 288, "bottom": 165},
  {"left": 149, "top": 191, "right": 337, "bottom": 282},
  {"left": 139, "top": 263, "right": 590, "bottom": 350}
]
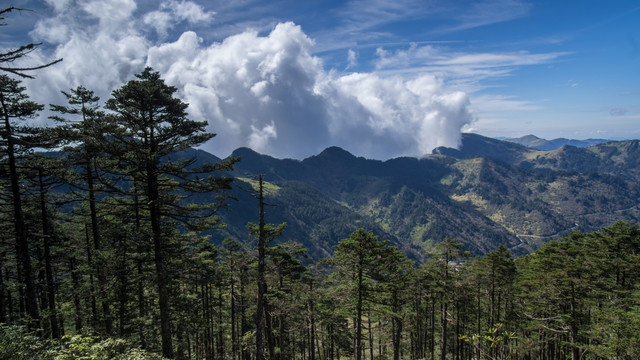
[{"left": 0, "top": 0, "right": 640, "bottom": 159}]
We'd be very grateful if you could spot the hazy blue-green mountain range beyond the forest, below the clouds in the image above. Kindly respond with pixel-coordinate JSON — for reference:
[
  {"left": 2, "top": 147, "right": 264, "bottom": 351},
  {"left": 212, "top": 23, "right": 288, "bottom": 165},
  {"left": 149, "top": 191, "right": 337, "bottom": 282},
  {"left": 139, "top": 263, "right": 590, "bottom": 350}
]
[{"left": 202, "top": 134, "right": 640, "bottom": 260}]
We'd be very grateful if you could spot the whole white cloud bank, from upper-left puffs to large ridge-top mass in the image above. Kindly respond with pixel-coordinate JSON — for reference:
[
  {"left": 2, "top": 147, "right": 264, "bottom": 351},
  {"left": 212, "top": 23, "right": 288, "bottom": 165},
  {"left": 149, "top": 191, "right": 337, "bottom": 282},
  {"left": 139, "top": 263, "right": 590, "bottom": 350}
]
[{"left": 30, "top": 0, "right": 472, "bottom": 159}]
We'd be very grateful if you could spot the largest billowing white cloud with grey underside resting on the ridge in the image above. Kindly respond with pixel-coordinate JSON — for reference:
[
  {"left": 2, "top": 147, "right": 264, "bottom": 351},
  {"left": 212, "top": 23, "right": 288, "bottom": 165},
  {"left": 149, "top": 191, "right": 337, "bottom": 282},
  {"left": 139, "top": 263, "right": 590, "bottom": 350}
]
[{"left": 148, "top": 23, "right": 472, "bottom": 158}]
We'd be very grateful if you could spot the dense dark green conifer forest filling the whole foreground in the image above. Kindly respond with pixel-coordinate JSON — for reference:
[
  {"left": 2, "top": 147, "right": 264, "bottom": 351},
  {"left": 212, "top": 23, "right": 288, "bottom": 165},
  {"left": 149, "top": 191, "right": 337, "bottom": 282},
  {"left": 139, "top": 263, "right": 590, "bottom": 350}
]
[{"left": 0, "top": 6, "right": 640, "bottom": 360}]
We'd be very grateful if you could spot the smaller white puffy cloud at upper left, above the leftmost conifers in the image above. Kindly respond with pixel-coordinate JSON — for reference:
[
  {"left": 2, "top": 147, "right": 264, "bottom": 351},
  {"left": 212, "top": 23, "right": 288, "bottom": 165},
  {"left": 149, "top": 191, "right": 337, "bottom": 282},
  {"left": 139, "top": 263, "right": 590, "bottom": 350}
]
[{"left": 28, "top": 0, "right": 150, "bottom": 104}]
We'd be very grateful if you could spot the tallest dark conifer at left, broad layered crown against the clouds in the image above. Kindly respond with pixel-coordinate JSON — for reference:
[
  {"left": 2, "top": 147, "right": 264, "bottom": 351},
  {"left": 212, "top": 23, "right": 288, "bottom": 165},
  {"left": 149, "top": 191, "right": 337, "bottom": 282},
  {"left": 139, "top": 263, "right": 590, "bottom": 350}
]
[{"left": 98, "top": 67, "right": 235, "bottom": 358}]
